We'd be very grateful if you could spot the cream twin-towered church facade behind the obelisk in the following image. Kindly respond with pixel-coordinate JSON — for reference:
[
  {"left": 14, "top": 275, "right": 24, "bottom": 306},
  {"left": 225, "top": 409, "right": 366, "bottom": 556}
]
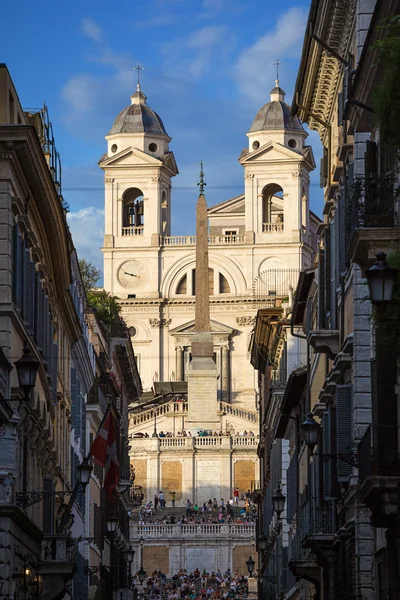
[{"left": 99, "top": 81, "right": 318, "bottom": 409}]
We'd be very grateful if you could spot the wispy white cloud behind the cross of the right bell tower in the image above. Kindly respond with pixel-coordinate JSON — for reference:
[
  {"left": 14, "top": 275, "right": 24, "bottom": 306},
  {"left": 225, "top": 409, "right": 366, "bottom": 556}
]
[{"left": 236, "top": 7, "right": 307, "bottom": 103}]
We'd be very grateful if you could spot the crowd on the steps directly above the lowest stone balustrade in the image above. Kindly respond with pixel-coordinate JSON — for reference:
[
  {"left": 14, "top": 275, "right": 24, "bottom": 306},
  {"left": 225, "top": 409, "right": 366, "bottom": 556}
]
[{"left": 139, "top": 487, "right": 256, "bottom": 525}]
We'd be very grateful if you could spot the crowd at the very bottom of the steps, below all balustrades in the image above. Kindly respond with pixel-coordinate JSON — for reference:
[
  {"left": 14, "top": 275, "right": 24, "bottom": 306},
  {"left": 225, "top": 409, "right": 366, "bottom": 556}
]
[{"left": 133, "top": 569, "right": 253, "bottom": 600}]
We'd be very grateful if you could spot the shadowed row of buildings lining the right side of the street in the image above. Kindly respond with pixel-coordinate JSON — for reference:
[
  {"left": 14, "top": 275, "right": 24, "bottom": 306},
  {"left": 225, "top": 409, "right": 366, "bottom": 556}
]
[{"left": 255, "top": 0, "right": 400, "bottom": 600}]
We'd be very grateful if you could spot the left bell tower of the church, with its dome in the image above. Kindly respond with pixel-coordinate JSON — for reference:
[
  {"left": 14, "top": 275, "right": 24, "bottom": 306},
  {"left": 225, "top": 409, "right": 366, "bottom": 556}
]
[{"left": 99, "top": 80, "right": 178, "bottom": 297}]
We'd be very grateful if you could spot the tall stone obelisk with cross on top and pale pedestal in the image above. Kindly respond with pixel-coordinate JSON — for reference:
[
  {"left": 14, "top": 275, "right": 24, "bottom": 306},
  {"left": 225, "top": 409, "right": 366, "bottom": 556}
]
[{"left": 186, "top": 162, "right": 220, "bottom": 430}]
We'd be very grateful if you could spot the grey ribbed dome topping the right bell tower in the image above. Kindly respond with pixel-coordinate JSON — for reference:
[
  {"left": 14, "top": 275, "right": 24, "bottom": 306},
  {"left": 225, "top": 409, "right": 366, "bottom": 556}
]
[{"left": 250, "top": 80, "right": 303, "bottom": 132}]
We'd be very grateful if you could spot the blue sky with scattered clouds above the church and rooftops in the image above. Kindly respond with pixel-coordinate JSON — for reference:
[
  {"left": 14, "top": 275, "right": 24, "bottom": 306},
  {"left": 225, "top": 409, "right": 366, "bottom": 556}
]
[{"left": 0, "top": 0, "right": 322, "bottom": 266}]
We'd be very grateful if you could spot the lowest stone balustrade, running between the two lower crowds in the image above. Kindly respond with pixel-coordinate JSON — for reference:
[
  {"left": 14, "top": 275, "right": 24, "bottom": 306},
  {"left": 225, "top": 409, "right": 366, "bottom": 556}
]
[{"left": 130, "top": 523, "right": 256, "bottom": 542}]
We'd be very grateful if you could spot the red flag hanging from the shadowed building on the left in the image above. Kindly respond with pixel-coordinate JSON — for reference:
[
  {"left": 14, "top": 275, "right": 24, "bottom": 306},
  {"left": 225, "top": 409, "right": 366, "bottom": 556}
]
[{"left": 90, "top": 410, "right": 119, "bottom": 496}]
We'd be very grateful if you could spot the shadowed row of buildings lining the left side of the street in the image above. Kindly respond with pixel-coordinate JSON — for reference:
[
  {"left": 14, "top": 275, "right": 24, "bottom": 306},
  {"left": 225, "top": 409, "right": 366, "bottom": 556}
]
[{"left": 0, "top": 65, "right": 141, "bottom": 600}]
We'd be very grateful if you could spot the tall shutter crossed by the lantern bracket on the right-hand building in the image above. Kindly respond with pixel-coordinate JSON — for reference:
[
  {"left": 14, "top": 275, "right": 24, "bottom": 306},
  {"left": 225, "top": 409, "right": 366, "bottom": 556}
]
[{"left": 336, "top": 385, "right": 353, "bottom": 481}]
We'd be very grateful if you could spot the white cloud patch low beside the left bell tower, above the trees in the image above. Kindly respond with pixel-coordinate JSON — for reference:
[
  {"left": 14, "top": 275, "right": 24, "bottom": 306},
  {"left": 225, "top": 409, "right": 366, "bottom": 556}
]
[{"left": 68, "top": 206, "right": 104, "bottom": 268}]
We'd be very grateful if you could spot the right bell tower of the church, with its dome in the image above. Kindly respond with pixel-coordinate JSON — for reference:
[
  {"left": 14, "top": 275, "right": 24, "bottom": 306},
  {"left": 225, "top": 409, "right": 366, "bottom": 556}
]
[{"left": 239, "top": 79, "right": 315, "bottom": 244}]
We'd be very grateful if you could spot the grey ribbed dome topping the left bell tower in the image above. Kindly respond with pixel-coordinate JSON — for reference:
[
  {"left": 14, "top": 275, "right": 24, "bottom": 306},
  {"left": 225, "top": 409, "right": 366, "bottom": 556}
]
[{"left": 108, "top": 86, "right": 168, "bottom": 136}]
